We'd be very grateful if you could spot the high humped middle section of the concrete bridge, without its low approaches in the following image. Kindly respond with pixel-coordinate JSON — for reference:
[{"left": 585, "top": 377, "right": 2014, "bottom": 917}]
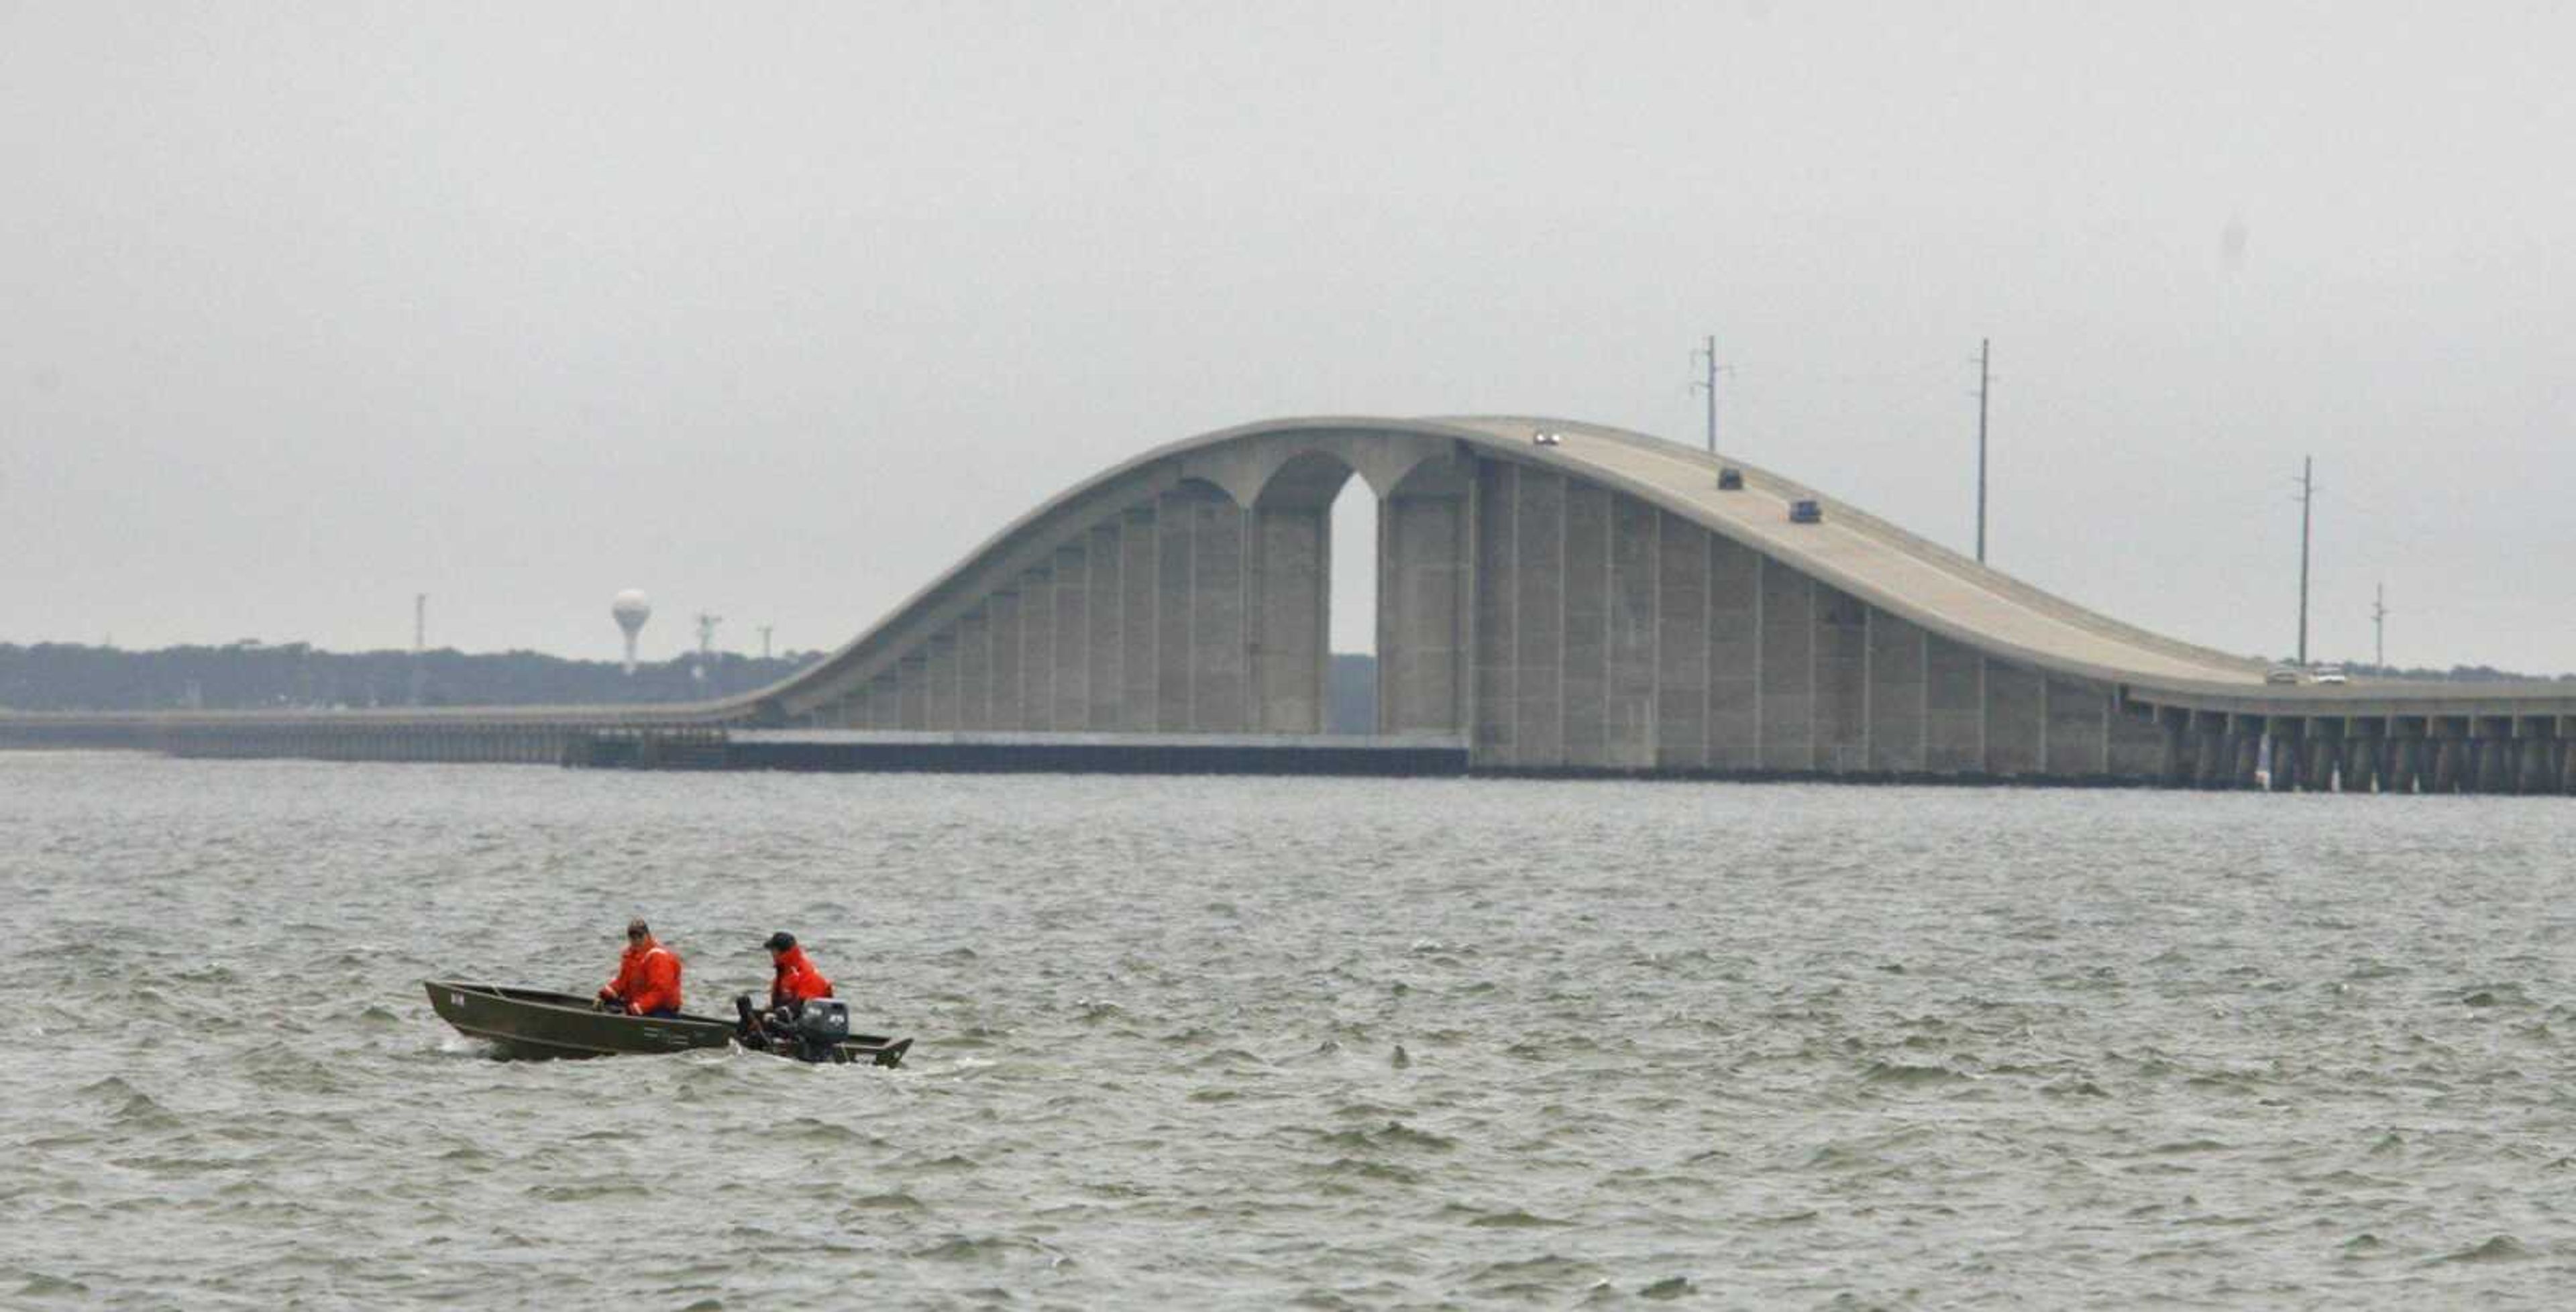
[{"left": 737, "top": 418, "right": 2262, "bottom": 776}]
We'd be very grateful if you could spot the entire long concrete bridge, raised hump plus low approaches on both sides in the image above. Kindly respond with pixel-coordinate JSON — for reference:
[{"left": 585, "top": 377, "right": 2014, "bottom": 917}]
[{"left": 0, "top": 418, "right": 2576, "bottom": 791}]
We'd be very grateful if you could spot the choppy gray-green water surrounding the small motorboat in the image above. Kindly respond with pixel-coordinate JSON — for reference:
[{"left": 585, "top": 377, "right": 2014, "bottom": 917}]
[{"left": 0, "top": 753, "right": 2576, "bottom": 1309}]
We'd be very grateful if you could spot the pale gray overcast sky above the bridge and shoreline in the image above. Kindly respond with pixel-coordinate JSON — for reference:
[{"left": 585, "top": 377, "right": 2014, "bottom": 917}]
[{"left": 0, "top": 0, "right": 2576, "bottom": 670}]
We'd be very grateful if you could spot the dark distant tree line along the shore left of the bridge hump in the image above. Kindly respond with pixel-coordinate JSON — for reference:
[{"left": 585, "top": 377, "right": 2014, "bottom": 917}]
[{"left": 0, "top": 642, "right": 822, "bottom": 712}]
